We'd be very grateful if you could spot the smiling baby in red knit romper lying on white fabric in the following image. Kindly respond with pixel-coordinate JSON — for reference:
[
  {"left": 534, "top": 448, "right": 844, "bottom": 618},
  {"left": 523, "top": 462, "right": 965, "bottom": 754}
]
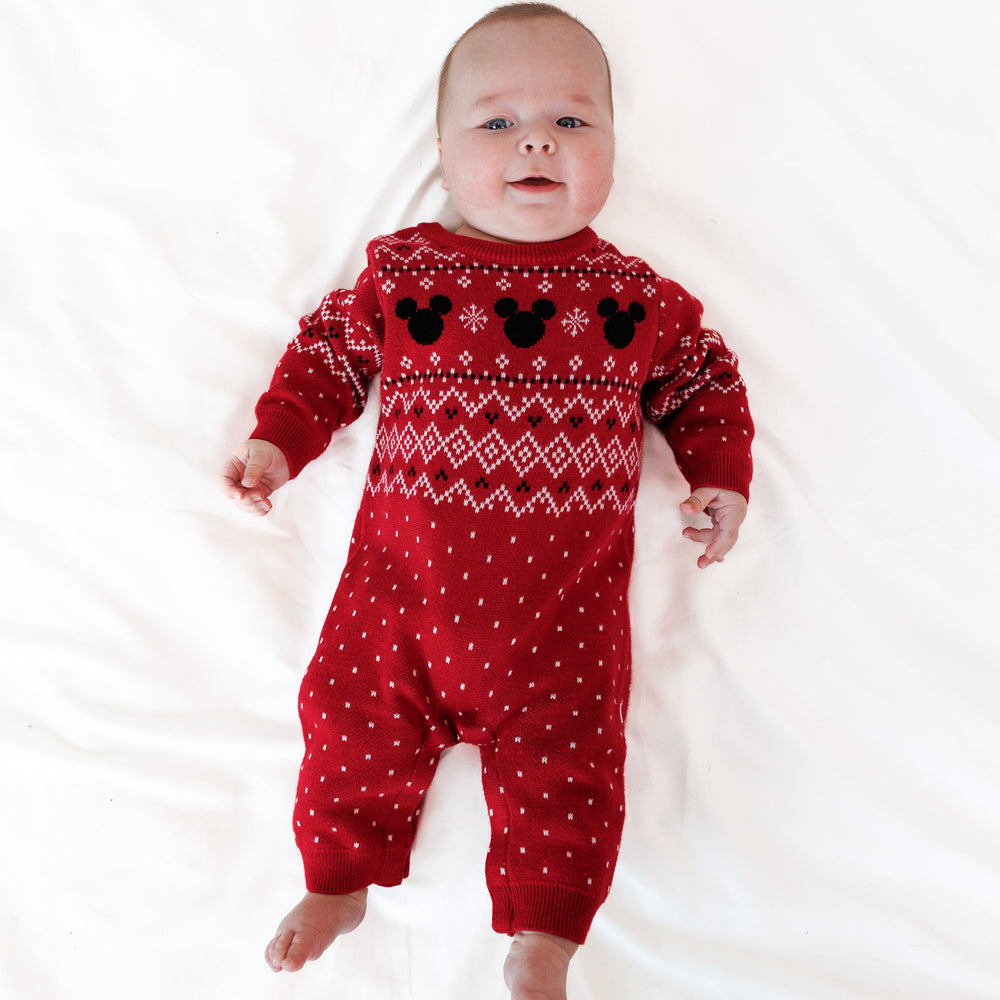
[{"left": 224, "top": 4, "right": 753, "bottom": 1000}]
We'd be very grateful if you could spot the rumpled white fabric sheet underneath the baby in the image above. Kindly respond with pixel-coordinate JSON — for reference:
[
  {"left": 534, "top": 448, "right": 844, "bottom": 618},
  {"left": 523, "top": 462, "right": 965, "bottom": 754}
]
[{"left": 0, "top": 0, "right": 1000, "bottom": 1000}]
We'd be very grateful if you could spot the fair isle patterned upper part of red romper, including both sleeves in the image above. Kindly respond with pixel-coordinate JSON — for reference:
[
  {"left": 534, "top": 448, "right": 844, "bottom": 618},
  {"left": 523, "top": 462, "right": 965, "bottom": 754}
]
[{"left": 254, "top": 224, "right": 753, "bottom": 508}]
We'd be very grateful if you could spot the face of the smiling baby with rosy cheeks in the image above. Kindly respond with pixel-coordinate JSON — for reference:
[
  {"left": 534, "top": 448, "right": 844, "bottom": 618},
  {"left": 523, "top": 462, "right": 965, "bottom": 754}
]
[{"left": 438, "top": 17, "right": 615, "bottom": 243}]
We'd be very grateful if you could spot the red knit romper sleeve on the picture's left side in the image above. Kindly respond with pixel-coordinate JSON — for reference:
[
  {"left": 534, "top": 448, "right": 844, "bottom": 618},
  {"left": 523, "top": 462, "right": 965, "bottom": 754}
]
[{"left": 251, "top": 268, "right": 384, "bottom": 477}]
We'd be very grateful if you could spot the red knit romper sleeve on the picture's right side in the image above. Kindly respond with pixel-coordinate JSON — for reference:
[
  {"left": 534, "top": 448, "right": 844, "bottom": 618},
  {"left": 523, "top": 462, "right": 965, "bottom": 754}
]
[{"left": 642, "top": 279, "right": 754, "bottom": 499}]
